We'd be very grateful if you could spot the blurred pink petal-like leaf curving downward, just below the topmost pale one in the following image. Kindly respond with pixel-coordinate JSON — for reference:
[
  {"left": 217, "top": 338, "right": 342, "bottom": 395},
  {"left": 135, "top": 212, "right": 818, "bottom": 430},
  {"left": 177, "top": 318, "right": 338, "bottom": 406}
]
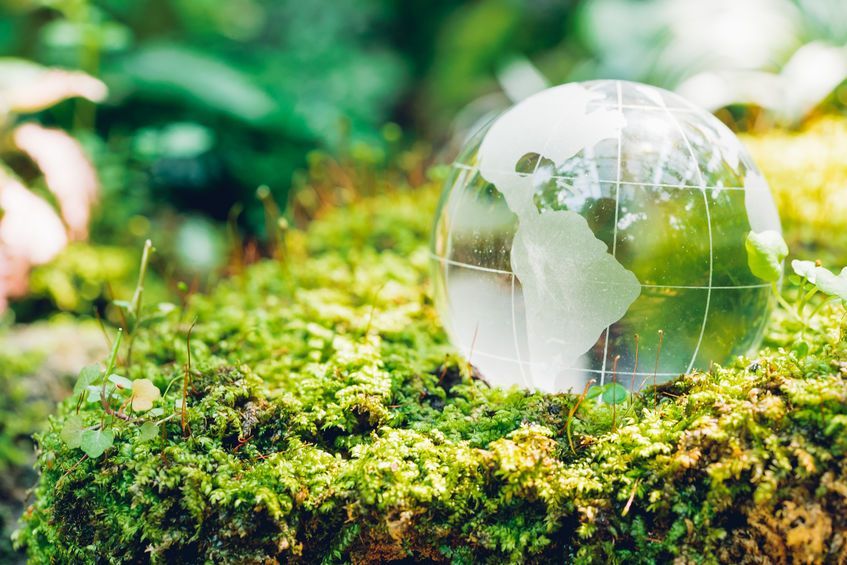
[{"left": 13, "top": 123, "right": 98, "bottom": 239}]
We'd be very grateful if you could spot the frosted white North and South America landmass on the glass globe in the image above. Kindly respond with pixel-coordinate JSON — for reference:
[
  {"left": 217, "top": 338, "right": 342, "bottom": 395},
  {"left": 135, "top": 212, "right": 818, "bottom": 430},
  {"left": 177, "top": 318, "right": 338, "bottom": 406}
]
[{"left": 479, "top": 84, "right": 641, "bottom": 391}]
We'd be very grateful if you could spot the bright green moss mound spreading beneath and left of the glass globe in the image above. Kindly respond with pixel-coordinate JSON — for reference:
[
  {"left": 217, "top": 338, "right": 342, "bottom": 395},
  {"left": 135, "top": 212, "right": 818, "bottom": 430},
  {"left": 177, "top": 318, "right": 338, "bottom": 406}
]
[{"left": 15, "top": 185, "right": 847, "bottom": 563}]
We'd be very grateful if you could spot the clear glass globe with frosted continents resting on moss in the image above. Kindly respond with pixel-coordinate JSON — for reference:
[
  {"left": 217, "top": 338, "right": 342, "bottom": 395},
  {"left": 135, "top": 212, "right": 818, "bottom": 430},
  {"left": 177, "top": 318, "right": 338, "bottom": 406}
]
[{"left": 432, "top": 81, "right": 780, "bottom": 391}]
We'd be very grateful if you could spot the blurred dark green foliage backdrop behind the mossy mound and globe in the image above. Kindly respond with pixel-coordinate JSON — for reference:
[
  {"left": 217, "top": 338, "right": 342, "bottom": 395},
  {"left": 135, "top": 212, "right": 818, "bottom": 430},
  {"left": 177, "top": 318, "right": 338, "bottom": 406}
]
[{"left": 0, "top": 0, "right": 847, "bottom": 249}]
